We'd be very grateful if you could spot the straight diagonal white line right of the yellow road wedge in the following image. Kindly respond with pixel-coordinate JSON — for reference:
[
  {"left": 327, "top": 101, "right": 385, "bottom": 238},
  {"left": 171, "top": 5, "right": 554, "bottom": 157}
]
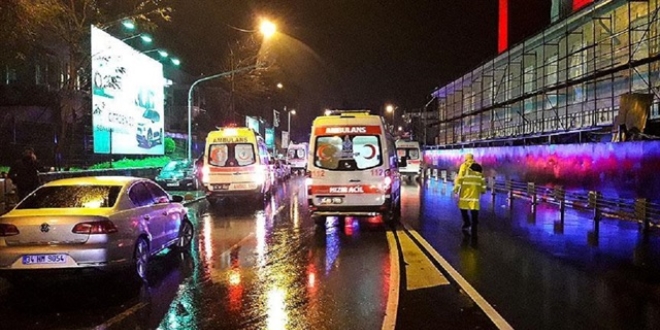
[{"left": 404, "top": 225, "right": 513, "bottom": 329}]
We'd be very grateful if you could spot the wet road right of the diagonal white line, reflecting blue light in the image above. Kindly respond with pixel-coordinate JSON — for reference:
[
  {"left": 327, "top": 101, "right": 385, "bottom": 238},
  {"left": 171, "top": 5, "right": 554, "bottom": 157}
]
[{"left": 402, "top": 180, "right": 660, "bottom": 330}]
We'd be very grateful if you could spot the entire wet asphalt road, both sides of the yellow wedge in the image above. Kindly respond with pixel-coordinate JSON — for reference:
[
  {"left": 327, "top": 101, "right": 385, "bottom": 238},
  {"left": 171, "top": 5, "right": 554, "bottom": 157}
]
[{"left": 0, "top": 178, "right": 660, "bottom": 329}]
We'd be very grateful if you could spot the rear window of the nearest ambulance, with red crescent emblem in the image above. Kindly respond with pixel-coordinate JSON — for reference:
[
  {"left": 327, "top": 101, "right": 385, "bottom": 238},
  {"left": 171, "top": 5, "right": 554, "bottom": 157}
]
[{"left": 314, "top": 135, "right": 383, "bottom": 171}]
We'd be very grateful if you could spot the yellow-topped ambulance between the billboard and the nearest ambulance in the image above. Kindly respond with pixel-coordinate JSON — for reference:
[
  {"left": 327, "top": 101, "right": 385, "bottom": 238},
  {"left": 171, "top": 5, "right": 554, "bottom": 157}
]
[{"left": 202, "top": 127, "right": 274, "bottom": 203}]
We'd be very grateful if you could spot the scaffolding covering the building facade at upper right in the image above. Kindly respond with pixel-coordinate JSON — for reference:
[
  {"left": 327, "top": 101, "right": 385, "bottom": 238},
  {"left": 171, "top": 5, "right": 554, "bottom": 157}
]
[{"left": 432, "top": 0, "right": 660, "bottom": 148}]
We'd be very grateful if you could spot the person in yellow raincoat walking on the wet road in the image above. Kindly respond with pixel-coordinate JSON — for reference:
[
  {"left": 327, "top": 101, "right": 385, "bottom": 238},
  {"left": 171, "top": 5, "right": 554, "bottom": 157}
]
[{"left": 453, "top": 160, "right": 486, "bottom": 234}]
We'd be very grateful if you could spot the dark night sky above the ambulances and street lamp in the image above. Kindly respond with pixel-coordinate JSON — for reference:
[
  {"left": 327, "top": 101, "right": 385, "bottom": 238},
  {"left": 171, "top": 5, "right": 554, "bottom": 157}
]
[{"left": 160, "top": 0, "right": 550, "bottom": 130}]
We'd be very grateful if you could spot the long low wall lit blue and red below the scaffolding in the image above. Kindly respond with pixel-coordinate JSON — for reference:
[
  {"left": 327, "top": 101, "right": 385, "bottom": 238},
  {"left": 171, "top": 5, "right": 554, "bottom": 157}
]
[{"left": 424, "top": 141, "right": 660, "bottom": 201}]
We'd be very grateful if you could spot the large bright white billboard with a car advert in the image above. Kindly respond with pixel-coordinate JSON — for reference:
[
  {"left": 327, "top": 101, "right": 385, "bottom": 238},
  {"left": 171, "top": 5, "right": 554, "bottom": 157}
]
[{"left": 91, "top": 26, "right": 165, "bottom": 155}]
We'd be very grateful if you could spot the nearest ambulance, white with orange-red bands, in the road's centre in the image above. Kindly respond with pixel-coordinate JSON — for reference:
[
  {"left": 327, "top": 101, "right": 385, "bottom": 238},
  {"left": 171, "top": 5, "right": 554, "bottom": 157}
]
[{"left": 306, "top": 110, "right": 404, "bottom": 224}]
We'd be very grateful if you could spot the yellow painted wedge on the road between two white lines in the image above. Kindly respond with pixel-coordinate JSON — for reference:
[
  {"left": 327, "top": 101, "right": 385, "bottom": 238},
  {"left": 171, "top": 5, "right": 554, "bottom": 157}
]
[{"left": 398, "top": 231, "right": 449, "bottom": 291}]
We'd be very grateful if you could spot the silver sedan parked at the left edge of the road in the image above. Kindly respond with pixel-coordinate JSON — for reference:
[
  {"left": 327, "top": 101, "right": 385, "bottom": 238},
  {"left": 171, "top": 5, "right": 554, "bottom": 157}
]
[{"left": 0, "top": 177, "right": 194, "bottom": 281}]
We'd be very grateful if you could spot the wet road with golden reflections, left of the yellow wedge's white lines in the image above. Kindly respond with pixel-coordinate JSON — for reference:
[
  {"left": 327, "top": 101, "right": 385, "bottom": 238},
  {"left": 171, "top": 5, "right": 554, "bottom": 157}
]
[{"left": 0, "top": 179, "right": 389, "bottom": 329}]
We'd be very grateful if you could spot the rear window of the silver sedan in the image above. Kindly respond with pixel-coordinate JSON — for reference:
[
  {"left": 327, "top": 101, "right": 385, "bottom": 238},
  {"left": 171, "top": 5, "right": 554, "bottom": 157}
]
[{"left": 16, "top": 185, "right": 121, "bottom": 209}]
